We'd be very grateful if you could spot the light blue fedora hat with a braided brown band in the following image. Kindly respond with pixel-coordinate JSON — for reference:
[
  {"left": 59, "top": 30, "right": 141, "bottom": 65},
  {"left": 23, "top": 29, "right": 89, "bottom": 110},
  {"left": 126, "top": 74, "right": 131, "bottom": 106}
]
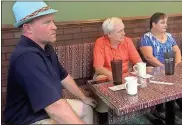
[{"left": 12, "top": 0, "right": 58, "bottom": 27}]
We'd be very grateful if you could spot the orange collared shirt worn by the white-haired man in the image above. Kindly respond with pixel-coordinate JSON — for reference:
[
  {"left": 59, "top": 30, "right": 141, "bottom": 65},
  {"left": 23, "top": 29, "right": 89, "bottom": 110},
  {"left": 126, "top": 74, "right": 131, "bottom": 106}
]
[{"left": 93, "top": 36, "right": 142, "bottom": 73}]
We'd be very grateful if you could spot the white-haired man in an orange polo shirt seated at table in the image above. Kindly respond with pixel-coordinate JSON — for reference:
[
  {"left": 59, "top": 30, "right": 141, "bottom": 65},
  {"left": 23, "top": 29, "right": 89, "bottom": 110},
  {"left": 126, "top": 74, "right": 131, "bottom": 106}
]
[{"left": 93, "top": 17, "right": 142, "bottom": 123}]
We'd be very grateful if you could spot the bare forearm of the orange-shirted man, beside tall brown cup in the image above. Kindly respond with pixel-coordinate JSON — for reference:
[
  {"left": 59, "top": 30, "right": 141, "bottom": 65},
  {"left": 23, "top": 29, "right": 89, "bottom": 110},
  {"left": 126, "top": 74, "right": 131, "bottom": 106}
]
[{"left": 95, "top": 67, "right": 112, "bottom": 79}]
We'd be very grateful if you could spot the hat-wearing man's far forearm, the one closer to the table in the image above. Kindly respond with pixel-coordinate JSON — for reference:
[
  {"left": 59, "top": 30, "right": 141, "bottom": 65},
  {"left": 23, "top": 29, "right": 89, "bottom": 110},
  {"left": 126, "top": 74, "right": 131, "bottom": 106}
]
[{"left": 61, "top": 75, "right": 85, "bottom": 100}]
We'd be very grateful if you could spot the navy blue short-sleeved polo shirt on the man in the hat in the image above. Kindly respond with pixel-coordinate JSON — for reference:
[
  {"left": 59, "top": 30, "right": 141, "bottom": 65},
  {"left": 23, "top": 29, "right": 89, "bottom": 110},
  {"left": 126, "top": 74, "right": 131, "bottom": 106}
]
[{"left": 4, "top": 36, "right": 68, "bottom": 124}]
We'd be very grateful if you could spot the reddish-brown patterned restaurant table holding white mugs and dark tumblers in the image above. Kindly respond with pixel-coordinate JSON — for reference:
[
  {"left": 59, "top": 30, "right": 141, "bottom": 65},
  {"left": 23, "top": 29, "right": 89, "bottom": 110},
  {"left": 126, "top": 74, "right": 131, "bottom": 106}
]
[{"left": 87, "top": 63, "right": 182, "bottom": 124}]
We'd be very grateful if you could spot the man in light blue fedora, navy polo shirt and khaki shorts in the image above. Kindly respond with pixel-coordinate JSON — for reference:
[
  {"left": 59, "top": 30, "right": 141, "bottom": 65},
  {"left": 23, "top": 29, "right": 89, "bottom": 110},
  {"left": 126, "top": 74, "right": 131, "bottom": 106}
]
[{"left": 4, "top": 0, "right": 95, "bottom": 124}]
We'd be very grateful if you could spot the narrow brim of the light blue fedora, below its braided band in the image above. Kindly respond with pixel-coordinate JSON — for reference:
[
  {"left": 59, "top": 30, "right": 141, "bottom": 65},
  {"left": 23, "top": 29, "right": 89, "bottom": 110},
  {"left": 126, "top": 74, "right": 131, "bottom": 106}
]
[{"left": 13, "top": 9, "right": 58, "bottom": 27}]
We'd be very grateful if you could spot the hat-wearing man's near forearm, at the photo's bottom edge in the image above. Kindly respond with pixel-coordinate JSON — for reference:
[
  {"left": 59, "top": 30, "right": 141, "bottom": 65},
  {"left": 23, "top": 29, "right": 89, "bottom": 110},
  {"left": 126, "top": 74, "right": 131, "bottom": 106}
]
[{"left": 45, "top": 99, "right": 85, "bottom": 124}]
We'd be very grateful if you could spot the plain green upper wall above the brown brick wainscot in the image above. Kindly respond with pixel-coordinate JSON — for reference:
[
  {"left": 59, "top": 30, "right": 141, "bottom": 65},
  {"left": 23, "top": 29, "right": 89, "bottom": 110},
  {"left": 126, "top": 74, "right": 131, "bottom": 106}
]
[{"left": 1, "top": 1, "right": 182, "bottom": 24}]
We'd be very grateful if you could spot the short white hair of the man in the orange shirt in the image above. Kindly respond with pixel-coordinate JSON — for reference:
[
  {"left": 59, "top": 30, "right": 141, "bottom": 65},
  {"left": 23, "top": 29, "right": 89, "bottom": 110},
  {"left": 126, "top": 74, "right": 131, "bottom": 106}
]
[{"left": 102, "top": 17, "right": 123, "bottom": 35}]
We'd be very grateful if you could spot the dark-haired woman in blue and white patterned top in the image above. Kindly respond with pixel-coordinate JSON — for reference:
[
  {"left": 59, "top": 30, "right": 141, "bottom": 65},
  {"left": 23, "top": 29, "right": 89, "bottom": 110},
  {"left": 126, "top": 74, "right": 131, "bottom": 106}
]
[{"left": 140, "top": 12, "right": 181, "bottom": 66}]
